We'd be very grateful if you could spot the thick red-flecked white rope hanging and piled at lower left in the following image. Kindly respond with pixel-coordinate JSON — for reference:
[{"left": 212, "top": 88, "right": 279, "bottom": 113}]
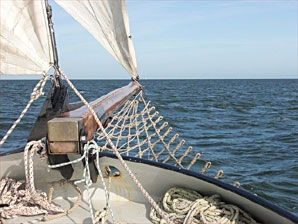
[{"left": 0, "top": 140, "right": 64, "bottom": 222}]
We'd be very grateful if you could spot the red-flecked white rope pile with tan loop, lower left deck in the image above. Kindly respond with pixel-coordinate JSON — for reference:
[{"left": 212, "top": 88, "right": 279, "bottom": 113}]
[{"left": 0, "top": 140, "right": 82, "bottom": 224}]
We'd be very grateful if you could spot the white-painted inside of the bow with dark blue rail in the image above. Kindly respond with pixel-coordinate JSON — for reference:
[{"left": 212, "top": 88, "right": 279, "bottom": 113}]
[{"left": 0, "top": 152, "right": 297, "bottom": 224}]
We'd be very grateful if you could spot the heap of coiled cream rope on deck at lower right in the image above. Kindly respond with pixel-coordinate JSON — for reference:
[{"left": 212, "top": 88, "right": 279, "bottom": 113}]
[{"left": 150, "top": 187, "right": 257, "bottom": 224}]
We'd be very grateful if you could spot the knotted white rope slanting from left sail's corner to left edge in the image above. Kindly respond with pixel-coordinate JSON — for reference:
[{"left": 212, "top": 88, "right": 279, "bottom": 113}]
[{"left": 0, "top": 75, "right": 48, "bottom": 148}]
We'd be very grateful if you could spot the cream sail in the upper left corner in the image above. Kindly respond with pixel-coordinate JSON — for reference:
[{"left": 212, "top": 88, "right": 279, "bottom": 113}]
[{"left": 0, "top": 0, "right": 53, "bottom": 75}]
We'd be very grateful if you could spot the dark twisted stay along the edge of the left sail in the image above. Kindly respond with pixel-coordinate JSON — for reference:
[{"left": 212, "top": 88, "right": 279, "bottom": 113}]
[{"left": 45, "top": 0, "right": 61, "bottom": 84}]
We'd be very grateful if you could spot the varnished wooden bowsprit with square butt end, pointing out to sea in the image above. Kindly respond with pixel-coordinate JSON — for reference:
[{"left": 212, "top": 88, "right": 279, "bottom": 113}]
[{"left": 48, "top": 82, "right": 142, "bottom": 154}]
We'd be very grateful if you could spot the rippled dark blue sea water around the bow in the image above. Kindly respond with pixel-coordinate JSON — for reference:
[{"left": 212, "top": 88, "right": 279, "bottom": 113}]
[{"left": 0, "top": 80, "right": 298, "bottom": 214}]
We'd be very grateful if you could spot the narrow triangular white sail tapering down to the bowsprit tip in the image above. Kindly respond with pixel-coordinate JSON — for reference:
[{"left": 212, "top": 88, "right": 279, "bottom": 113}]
[{"left": 55, "top": 0, "right": 138, "bottom": 79}]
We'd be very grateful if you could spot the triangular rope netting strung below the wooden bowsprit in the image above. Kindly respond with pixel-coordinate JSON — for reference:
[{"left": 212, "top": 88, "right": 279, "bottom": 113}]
[{"left": 96, "top": 92, "right": 217, "bottom": 175}]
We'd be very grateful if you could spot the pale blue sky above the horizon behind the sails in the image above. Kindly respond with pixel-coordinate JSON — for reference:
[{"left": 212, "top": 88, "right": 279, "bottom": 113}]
[{"left": 2, "top": 0, "right": 297, "bottom": 79}]
